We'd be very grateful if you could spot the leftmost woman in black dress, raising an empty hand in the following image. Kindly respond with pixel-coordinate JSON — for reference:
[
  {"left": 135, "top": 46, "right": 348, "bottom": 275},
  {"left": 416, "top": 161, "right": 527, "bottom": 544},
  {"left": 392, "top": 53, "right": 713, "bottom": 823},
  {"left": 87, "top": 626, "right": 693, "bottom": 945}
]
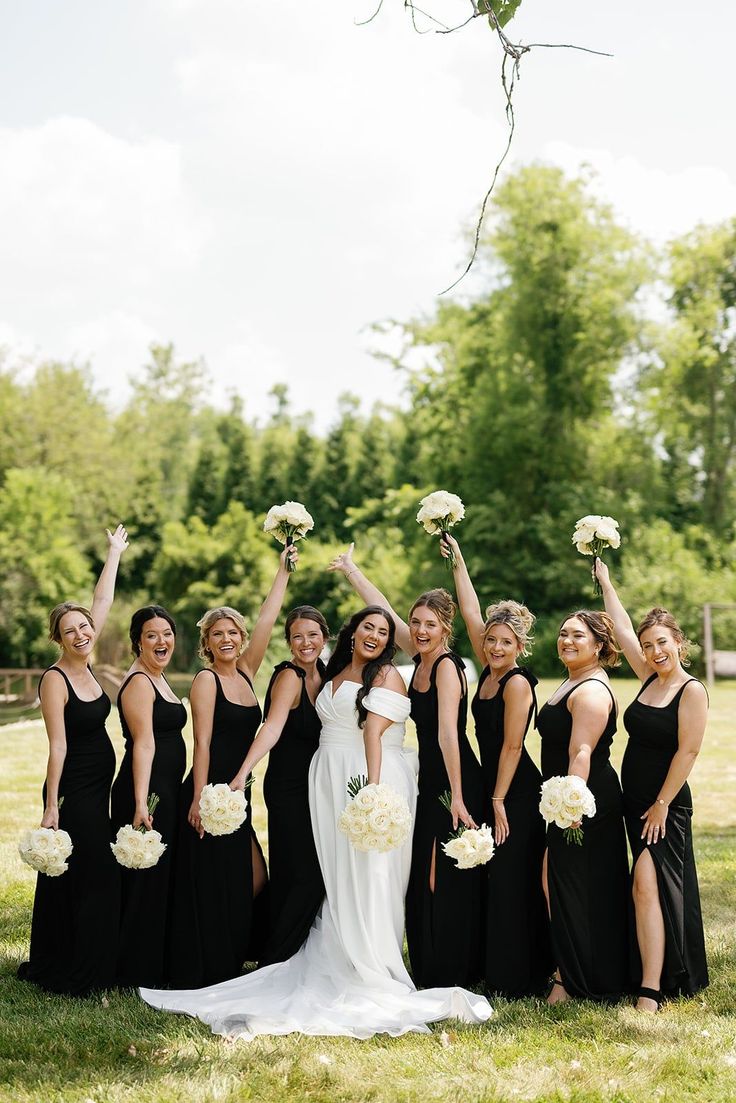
[{"left": 18, "top": 525, "right": 128, "bottom": 996}]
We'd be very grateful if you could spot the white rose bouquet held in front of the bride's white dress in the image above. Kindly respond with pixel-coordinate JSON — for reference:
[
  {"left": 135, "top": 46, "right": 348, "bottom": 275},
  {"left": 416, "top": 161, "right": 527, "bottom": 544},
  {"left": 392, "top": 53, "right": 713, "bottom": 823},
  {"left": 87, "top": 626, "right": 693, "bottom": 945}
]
[{"left": 338, "top": 775, "right": 412, "bottom": 853}]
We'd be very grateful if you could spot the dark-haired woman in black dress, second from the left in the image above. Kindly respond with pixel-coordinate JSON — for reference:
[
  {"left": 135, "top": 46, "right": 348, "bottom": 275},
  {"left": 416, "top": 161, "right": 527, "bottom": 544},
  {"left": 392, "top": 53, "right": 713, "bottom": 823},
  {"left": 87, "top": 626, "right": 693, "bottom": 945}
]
[{"left": 111, "top": 606, "right": 186, "bottom": 987}]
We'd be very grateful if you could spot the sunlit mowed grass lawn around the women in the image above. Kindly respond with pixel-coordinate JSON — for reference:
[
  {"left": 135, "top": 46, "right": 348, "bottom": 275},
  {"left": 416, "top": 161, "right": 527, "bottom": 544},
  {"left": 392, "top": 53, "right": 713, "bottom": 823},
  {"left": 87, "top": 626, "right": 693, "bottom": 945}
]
[{"left": 0, "top": 681, "right": 736, "bottom": 1103}]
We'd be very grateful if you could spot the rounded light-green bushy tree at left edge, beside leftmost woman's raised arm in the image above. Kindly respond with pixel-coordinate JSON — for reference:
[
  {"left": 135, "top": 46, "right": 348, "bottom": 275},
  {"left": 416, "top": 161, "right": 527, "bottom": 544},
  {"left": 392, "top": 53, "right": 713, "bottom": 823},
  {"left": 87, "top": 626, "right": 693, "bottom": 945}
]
[{"left": 0, "top": 467, "right": 93, "bottom": 666}]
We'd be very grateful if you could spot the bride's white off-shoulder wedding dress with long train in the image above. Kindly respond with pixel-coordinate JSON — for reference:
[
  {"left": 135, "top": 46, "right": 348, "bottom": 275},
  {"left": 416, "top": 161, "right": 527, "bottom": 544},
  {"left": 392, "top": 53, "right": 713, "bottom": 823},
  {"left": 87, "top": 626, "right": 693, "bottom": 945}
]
[{"left": 140, "top": 682, "right": 491, "bottom": 1038}]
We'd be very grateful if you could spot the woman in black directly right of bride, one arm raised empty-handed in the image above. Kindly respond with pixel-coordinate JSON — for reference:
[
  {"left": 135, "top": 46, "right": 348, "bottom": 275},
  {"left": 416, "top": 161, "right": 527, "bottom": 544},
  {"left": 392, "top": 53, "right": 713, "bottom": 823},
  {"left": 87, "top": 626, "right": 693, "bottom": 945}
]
[{"left": 331, "top": 544, "right": 483, "bottom": 987}]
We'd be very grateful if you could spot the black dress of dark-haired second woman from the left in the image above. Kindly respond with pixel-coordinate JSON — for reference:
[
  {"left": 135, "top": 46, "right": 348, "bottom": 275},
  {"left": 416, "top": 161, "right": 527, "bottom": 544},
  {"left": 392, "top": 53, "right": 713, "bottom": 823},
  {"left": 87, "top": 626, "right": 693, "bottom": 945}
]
[{"left": 111, "top": 671, "right": 186, "bottom": 988}]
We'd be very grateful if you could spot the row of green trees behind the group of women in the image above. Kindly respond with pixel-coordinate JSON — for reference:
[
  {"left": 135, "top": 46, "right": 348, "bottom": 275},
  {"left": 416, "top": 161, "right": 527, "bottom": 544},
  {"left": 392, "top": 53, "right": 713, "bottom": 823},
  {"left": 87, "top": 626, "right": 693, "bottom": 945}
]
[{"left": 0, "top": 164, "right": 736, "bottom": 674}]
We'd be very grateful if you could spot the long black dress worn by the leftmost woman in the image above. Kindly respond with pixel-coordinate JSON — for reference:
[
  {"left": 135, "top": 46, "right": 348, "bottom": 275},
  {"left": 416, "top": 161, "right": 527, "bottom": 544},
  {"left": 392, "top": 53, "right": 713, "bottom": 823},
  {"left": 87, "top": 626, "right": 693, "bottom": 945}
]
[{"left": 18, "top": 666, "right": 120, "bottom": 996}]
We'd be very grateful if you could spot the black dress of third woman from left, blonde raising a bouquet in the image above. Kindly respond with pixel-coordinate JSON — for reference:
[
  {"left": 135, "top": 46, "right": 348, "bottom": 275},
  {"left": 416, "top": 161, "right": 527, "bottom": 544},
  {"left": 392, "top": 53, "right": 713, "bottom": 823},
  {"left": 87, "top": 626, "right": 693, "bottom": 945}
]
[{"left": 168, "top": 670, "right": 265, "bottom": 988}]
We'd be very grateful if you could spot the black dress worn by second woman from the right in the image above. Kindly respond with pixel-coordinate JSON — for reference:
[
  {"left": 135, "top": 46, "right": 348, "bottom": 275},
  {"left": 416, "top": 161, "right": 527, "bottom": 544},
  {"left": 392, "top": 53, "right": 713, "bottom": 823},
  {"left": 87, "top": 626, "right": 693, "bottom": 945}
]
[{"left": 537, "top": 678, "right": 630, "bottom": 1002}]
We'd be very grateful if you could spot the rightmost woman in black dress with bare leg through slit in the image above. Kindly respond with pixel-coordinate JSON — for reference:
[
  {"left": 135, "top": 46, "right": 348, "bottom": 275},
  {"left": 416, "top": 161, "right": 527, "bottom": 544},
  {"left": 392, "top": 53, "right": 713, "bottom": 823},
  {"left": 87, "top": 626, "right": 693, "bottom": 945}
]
[{"left": 595, "top": 559, "right": 708, "bottom": 1011}]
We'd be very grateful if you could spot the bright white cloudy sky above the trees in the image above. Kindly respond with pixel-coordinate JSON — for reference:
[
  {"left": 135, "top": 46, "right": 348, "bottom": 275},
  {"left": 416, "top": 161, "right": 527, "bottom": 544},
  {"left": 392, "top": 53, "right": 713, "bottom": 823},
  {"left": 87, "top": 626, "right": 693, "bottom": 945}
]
[{"left": 0, "top": 0, "right": 736, "bottom": 426}]
